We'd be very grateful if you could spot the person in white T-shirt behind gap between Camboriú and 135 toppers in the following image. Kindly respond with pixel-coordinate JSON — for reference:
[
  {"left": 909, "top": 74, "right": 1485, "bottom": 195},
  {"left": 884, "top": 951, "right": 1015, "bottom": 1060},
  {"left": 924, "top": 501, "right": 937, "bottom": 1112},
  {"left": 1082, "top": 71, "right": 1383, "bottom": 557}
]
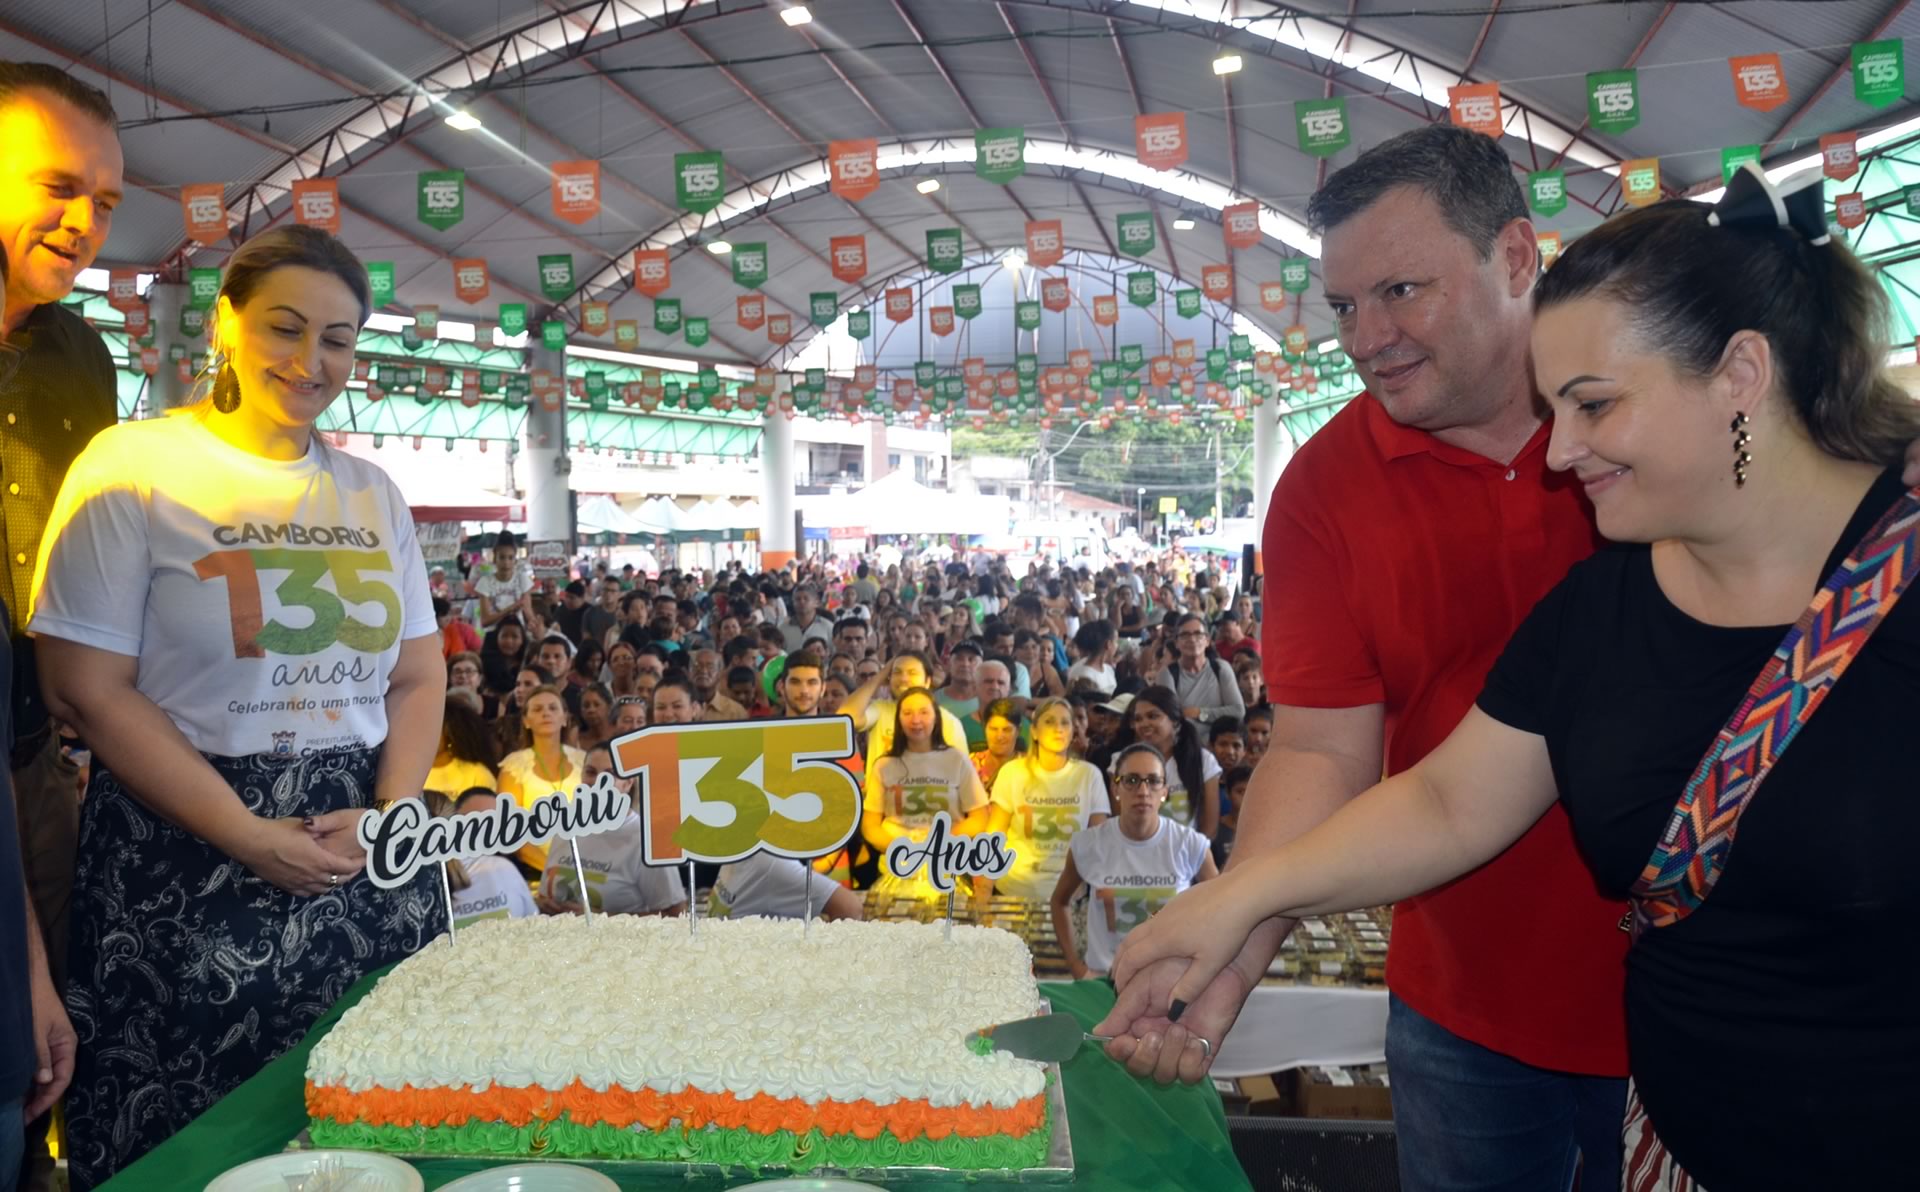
[{"left": 540, "top": 741, "right": 687, "bottom": 916}]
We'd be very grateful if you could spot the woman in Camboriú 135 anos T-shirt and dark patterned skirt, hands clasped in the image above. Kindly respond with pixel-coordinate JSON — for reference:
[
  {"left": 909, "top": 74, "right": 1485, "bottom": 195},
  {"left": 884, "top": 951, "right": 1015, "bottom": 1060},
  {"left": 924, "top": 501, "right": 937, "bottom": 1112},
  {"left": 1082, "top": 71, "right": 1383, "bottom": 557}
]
[{"left": 29, "top": 225, "right": 447, "bottom": 1188}]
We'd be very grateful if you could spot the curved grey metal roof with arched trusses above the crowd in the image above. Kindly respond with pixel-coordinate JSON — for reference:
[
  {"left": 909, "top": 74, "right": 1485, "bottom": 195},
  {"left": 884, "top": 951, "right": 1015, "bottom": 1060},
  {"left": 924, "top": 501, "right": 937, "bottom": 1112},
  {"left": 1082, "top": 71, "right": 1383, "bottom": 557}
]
[{"left": 0, "top": 0, "right": 1920, "bottom": 365}]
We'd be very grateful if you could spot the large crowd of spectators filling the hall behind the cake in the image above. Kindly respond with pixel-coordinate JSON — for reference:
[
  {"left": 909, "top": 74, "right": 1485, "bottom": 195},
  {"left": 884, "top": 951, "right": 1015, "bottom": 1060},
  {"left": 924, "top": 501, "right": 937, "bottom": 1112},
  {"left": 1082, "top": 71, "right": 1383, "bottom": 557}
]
[{"left": 426, "top": 532, "right": 1271, "bottom": 932}]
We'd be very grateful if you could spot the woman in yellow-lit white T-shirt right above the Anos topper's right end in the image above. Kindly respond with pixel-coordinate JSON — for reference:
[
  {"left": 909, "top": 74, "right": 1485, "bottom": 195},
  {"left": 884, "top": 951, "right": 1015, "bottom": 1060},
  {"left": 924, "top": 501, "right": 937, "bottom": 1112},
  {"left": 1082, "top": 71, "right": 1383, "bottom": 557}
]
[{"left": 973, "top": 699, "right": 1110, "bottom": 902}]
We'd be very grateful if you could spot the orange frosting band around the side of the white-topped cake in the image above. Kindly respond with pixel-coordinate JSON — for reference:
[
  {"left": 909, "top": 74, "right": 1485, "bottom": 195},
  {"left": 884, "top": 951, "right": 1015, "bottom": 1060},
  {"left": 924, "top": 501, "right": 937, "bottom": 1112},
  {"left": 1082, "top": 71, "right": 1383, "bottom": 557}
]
[{"left": 307, "top": 1081, "right": 1046, "bottom": 1142}]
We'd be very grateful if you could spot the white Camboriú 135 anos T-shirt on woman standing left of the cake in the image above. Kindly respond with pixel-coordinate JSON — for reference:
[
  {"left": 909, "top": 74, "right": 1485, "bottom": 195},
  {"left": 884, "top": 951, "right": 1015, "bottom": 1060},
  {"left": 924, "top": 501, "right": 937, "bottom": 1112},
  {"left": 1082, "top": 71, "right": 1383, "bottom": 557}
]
[{"left": 27, "top": 411, "right": 438, "bottom": 756}]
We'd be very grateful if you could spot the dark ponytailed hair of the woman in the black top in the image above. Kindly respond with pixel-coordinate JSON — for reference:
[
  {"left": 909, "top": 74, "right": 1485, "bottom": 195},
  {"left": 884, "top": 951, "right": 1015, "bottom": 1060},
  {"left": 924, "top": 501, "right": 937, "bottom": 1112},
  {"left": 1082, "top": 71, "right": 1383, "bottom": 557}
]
[{"left": 1534, "top": 202, "right": 1920, "bottom": 465}]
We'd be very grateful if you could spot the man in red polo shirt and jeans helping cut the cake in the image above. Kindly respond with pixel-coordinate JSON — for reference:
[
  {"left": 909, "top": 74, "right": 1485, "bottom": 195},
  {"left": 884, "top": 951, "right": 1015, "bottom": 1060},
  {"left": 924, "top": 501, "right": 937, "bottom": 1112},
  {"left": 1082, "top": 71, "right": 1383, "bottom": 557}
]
[{"left": 1100, "top": 125, "right": 1628, "bottom": 1192}]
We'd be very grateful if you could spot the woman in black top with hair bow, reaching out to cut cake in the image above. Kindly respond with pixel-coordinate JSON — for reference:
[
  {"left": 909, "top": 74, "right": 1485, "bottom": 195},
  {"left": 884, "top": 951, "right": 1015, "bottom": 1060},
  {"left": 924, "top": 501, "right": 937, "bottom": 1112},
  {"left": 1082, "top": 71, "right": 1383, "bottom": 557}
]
[{"left": 1114, "top": 169, "right": 1920, "bottom": 1192}]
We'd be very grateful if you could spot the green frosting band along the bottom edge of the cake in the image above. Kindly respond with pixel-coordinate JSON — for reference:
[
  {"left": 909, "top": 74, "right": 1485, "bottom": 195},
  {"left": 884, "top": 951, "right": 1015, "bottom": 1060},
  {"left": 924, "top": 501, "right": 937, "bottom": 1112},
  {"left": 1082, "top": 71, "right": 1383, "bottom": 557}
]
[{"left": 311, "top": 1108, "right": 1052, "bottom": 1175}]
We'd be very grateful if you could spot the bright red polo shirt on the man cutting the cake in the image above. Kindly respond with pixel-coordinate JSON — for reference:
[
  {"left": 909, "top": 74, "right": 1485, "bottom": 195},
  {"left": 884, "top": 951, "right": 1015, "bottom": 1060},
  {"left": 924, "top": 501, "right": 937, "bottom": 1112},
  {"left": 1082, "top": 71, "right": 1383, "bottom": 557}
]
[{"left": 1261, "top": 395, "right": 1628, "bottom": 1077}]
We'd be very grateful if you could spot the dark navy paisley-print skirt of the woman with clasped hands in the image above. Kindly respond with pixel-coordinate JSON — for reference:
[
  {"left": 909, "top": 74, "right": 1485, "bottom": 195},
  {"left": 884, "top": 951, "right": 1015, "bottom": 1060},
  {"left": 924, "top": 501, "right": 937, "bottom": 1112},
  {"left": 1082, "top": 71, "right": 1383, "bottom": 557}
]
[{"left": 67, "top": 749, "right": 445, "bottom": 1190}]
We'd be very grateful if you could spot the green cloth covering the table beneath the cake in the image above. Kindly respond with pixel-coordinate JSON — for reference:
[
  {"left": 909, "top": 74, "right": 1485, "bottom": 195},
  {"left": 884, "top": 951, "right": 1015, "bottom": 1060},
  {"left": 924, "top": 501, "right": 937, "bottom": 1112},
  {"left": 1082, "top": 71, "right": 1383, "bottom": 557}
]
[{"left": 100, "top": 973, "right": 1250, "bottom": 1192}]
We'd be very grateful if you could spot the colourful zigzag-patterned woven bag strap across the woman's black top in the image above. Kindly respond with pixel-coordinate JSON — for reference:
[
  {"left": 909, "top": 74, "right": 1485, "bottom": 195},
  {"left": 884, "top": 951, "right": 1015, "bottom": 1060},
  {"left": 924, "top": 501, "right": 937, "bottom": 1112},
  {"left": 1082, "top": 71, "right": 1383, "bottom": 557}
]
[{"left": 1632, "top": 477, "right": 1920, "bottom": 937}]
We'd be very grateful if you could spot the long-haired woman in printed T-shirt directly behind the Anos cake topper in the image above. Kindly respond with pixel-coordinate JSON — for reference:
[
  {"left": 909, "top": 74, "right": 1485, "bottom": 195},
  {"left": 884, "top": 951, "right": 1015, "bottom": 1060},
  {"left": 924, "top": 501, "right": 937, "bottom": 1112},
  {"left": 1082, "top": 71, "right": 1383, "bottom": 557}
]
[{"left": 860, "top": 687, "right": 987, "bottom": 898}]
